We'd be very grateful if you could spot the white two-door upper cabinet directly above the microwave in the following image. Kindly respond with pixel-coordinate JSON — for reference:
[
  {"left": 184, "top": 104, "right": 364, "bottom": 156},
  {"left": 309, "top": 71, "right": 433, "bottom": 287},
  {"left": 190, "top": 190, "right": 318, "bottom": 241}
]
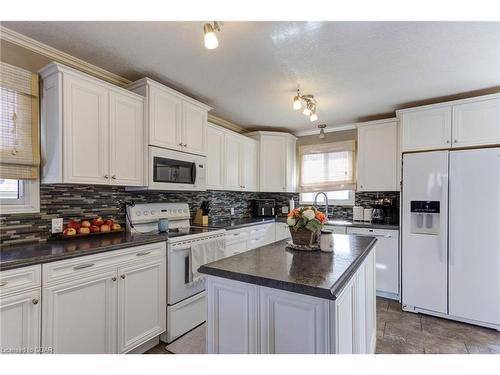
[{"left": 127, "top": 78, "right": 211, "bottom": 155}]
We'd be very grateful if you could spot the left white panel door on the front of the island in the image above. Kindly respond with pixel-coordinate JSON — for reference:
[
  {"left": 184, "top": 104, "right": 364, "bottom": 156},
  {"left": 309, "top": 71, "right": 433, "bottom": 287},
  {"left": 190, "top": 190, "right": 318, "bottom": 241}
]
[{"left": 207, "top": 276, "right": 258, "bottom": 354}]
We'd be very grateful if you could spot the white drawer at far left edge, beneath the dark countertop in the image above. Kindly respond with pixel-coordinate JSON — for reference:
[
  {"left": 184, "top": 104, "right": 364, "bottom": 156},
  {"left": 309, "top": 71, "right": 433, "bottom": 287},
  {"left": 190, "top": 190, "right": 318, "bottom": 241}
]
[{"left": 0, "top": 265, "right": 41, "bottom": 296}]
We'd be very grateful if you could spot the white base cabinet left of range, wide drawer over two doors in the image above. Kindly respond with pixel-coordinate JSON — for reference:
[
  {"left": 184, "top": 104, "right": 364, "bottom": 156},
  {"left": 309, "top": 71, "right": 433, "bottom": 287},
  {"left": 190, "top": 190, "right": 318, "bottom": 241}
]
[{"left": 42, "top": 243, "right": 166, "bottom": 353}]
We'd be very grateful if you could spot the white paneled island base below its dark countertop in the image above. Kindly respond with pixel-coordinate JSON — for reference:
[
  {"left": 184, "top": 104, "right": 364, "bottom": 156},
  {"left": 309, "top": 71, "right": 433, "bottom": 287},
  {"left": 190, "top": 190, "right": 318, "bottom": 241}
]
[{"left": 207, "top": 249, "right": 376, "bottom": 354}]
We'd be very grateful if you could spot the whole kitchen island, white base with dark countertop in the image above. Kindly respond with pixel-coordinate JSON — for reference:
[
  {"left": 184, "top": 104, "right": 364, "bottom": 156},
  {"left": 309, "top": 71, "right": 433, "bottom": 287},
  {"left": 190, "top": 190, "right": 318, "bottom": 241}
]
[{"left": 199, "top": 235, "right": 376, "bottom": 354}]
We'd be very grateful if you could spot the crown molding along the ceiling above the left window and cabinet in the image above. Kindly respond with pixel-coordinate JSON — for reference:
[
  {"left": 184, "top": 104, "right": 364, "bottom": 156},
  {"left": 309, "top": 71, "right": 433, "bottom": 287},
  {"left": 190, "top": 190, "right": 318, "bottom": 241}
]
[{"left": 0, "top": 25, "right": 131, "bottom": 86}]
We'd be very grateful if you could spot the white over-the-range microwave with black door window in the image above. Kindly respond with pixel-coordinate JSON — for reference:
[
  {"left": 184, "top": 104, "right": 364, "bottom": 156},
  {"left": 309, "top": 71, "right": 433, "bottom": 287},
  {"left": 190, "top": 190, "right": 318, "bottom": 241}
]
[{"left": 148, "top": 146, "right": 207, "bottom": 191}]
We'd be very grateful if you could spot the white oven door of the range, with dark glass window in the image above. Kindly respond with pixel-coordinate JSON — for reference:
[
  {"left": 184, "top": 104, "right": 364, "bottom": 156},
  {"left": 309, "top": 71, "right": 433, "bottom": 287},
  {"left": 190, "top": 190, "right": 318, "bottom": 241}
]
[{"left": 167, "top": 243, "right": 205, "bottom": 305}]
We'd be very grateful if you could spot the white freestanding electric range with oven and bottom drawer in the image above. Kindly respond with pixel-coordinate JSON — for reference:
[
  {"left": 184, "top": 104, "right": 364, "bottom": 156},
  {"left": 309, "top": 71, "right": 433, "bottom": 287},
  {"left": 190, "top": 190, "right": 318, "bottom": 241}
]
[{"left": 127, "top": 203, "right": 225, "bottom": 343}]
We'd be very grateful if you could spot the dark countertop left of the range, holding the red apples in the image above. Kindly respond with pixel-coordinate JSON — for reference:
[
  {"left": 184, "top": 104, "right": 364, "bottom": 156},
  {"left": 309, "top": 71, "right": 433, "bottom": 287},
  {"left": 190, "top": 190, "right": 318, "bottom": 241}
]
[{"left": 0, "top": 232, "right": 168, "bottom": 270}]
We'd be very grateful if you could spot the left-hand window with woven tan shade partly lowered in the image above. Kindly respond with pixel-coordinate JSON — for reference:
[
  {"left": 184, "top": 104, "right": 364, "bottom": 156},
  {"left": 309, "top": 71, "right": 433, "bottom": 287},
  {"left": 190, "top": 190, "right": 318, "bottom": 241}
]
[{"left": 0, "top": 62, "right": 40, "bottom": 213}]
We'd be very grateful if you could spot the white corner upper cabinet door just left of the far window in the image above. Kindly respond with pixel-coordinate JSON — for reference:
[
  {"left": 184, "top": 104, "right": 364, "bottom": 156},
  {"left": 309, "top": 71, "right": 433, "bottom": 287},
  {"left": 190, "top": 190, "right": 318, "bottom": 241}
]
[{"left": 259, "top": 135, "right": 286, "bottom": 192}]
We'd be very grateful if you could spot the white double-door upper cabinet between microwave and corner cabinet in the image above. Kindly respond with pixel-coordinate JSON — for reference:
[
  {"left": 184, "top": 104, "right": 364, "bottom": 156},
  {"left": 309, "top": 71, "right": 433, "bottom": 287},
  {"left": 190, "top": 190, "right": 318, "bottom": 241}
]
[{"left": 207, "top": 124, "right": 257, "bottom": 191}]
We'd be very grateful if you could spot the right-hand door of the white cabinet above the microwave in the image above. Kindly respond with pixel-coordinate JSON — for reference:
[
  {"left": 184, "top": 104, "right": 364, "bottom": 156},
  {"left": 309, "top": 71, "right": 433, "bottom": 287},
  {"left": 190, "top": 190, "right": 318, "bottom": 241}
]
[{"left": 181, "top": 102, "right": 207, "bottom": 155}]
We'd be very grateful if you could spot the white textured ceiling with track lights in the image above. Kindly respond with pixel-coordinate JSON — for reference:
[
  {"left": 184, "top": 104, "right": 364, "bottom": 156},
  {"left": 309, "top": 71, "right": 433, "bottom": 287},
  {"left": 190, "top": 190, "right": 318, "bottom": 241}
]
[{"left": 2, "top": 22, "right": 500, "bottom": 131}]
